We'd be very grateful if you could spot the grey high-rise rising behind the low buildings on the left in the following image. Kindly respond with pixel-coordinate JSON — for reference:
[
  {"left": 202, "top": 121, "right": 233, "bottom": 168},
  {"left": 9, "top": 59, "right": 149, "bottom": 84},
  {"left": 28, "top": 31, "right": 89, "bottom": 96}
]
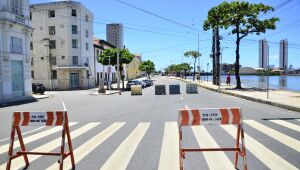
[{"left": 106, "top": 23, "right": 123, "bottom": 48}]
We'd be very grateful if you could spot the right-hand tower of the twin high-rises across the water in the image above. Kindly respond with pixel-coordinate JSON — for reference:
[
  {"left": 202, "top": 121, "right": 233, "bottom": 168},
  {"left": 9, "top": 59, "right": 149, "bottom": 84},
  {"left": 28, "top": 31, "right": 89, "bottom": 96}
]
[{"left": 279, "top": 39, "right": 288, "bottom": 70}]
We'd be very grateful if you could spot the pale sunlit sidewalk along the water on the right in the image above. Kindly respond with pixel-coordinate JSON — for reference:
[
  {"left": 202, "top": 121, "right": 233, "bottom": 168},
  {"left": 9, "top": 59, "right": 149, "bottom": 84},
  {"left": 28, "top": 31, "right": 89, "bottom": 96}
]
[{"left": 173, "top": 77, "right": 300, "bottom": 112}]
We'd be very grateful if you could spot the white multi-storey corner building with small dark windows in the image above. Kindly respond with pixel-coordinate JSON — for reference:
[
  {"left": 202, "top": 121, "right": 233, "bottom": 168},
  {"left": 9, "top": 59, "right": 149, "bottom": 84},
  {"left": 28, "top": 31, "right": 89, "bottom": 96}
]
[{"left": 30, "top": 1, "right": 95, "bottom": 90}]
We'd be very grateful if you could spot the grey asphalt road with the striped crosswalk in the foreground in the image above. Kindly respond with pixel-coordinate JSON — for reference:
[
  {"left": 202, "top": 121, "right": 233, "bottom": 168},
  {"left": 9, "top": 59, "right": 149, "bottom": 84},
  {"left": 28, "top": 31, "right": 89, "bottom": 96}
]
[{"left": 0, "top": 77, "right": 300, "bottom": 170}]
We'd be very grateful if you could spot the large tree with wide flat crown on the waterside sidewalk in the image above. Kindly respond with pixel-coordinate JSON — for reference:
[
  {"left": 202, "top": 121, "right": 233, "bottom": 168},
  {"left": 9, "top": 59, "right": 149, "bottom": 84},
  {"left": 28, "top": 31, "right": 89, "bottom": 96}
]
[{"left": 203, "top": 1, "right": 279, "bottom": 89}]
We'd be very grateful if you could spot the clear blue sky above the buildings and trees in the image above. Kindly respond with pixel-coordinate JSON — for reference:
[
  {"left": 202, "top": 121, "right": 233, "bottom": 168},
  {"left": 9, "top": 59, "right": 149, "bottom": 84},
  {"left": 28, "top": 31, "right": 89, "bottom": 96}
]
[{"left": 30, "top": 0, "right": 300, "bottom": 70}]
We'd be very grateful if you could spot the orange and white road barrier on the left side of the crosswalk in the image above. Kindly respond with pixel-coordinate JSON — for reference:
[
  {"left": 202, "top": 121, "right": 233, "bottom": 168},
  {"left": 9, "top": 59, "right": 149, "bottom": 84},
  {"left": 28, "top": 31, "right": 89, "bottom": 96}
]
[{"left": 6, "top": 107, "right": 75, "bottom": 170}]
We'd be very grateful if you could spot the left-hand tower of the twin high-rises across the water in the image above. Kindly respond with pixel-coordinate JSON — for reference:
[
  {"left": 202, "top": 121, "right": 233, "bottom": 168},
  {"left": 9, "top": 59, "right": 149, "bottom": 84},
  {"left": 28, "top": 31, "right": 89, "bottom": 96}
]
[{"left": 259, "top": 39, "right": 269, "bottom": 68}]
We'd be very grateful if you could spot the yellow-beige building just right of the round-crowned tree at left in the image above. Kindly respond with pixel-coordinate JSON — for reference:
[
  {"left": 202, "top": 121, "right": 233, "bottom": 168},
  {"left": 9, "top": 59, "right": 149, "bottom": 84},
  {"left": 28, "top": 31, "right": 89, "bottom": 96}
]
[{"left": 126, "top": 55, "right": 142, "bottom": 80}]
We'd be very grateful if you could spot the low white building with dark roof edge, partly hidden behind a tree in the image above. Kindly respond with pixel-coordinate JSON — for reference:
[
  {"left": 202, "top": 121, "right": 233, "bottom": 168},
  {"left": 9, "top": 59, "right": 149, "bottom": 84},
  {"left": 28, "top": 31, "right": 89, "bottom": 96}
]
[{"left": 93, "top": 38, "right": 117, "bottom": 85}]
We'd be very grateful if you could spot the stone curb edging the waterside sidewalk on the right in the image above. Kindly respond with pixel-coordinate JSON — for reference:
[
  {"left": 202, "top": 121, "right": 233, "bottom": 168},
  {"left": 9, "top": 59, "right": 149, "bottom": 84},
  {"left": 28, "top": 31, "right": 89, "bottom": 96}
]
[{"left": 171, "top": 77, "right": 300, "bottom": 112}]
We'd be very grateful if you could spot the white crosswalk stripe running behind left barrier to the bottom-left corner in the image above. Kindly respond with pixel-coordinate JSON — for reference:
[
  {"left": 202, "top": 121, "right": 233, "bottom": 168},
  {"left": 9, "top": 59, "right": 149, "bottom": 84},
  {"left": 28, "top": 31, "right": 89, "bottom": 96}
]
[{"left": 0, "top": 122, "right": 100, "bottom": 169}]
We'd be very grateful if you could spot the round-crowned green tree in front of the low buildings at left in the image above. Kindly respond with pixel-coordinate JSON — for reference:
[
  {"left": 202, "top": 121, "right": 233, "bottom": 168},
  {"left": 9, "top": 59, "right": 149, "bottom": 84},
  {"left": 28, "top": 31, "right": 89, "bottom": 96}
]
[{"left": 98, "top": 48, "right": 134, "bottom": 89}]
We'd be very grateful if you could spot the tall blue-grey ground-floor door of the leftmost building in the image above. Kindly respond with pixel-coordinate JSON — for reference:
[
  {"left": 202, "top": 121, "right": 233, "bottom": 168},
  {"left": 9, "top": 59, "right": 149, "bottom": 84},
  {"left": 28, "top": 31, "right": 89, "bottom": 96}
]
[{"left": 10, "top": 60, "right": 24, "bottom": 97}]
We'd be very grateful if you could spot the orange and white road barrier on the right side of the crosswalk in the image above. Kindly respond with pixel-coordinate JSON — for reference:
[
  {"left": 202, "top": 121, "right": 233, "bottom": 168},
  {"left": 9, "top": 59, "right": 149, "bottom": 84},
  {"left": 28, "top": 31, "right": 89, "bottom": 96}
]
[{"left": 178, "top": 108, "right": 247, "bottom": 170}]
